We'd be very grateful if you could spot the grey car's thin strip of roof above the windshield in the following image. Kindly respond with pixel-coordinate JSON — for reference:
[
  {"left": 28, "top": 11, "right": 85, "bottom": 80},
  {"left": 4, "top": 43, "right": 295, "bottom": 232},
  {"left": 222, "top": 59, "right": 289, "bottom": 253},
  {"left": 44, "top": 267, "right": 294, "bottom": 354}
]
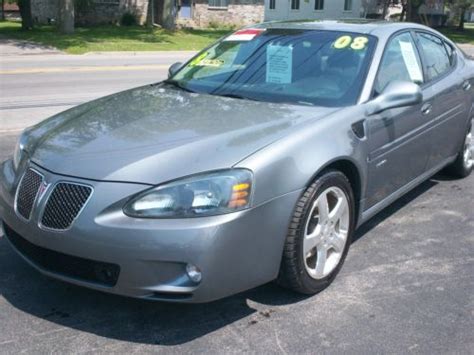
[{"left": 259, "top": 19, "right": 427, "bottom": 35}]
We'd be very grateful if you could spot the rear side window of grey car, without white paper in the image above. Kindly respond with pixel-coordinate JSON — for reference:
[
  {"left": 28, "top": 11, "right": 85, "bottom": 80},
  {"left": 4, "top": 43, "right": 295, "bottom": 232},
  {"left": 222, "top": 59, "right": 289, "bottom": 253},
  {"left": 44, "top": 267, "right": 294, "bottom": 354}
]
[{"left": 418, "top": 33, "right": 451, "bottom": 80}]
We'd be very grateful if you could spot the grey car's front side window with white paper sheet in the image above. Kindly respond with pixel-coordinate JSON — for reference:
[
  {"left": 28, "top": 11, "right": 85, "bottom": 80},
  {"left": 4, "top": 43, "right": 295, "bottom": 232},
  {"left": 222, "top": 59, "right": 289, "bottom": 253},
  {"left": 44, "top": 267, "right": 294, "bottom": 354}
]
[{"left": 374, "top": 32, "right": 423, "bottom": 96}]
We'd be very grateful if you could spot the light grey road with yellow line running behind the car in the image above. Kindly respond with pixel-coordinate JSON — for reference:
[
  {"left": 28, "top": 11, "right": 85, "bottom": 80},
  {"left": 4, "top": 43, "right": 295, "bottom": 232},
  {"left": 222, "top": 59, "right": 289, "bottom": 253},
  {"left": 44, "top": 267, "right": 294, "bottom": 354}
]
[{"left": 0, "top": 52, "right": 193, "bottom": 132}]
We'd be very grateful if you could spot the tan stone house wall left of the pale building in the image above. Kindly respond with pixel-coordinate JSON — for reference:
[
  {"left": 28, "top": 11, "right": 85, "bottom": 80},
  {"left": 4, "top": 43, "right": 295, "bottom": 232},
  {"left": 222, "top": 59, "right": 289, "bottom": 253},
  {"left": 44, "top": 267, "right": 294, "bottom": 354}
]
[{"left": 191, "top": 0, "right": 264, "bottom": 27}]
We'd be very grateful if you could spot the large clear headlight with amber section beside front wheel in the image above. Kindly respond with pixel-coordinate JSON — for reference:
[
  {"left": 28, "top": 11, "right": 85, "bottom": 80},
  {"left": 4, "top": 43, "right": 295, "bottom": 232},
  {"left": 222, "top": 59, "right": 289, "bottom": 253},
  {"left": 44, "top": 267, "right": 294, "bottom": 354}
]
[{"left": 123, "top": 169, "right": 252, "bottom": 218}]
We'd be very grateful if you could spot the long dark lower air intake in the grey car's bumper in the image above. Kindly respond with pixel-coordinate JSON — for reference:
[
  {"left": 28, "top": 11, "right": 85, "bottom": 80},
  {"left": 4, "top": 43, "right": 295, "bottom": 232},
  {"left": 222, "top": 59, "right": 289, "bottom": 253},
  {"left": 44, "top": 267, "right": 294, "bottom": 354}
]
[{"left": 3, "top": 223, "right": 120, "bottom": 287}]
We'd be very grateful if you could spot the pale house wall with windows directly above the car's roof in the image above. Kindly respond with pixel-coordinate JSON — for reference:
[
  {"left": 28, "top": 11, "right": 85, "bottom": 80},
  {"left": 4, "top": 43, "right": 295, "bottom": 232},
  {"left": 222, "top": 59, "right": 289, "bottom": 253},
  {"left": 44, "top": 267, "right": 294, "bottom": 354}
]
[{"left": 265, "top": 0, "right": 363, "bottom": 21}]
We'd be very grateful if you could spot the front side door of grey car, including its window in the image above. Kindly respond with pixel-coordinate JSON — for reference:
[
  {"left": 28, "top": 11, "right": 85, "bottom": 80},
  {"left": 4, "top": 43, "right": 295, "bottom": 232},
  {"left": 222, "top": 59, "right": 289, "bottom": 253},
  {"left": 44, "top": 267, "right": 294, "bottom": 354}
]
[{"left": 366, "top": 31, "right": 433, "bottom": 208}]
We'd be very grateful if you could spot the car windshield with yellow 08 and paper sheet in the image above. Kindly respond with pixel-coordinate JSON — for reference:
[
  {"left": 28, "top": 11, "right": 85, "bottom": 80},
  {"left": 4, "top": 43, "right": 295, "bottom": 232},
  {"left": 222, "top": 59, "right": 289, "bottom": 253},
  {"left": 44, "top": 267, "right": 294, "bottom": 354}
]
[{"left": 169, "top": 28, "right": 376, "bottom": 106}]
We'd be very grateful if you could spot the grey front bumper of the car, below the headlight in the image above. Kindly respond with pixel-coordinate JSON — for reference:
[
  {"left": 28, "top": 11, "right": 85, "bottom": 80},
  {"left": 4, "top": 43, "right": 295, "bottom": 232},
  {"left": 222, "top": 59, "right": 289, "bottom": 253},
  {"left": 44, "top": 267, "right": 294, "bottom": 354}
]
[{"left": 0, "top": 161, "right": 300, "bottom": 302}]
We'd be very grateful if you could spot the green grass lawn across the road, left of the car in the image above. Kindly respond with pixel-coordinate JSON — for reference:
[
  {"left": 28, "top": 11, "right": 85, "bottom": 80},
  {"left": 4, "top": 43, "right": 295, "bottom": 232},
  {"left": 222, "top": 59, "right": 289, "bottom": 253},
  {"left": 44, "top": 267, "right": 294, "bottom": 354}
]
[{"left": 0, "top": 21, "right": 229, "bottom": 54}]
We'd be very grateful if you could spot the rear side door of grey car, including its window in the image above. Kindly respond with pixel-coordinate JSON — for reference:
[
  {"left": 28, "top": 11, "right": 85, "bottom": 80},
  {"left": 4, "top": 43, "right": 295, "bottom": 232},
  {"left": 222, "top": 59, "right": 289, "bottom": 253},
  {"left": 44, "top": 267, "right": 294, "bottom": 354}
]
[{"left": 416, "top": 31, "right": 469, "bottom": 169}]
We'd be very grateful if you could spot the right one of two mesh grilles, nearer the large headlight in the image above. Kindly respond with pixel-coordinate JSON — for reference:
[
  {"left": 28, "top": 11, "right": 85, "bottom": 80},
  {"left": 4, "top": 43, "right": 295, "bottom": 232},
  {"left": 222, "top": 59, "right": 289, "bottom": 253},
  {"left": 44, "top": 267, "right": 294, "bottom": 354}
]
[{"left": 41, "top": 182, "right": 92, "bottom": 230}]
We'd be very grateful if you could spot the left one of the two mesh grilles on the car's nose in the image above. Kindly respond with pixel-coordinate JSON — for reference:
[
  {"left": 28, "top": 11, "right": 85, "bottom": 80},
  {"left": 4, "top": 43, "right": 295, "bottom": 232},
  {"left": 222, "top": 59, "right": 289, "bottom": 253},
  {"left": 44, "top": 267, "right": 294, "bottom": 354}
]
[{"left": 16, "top": 169, "right": 43, "bottom": 219}]
